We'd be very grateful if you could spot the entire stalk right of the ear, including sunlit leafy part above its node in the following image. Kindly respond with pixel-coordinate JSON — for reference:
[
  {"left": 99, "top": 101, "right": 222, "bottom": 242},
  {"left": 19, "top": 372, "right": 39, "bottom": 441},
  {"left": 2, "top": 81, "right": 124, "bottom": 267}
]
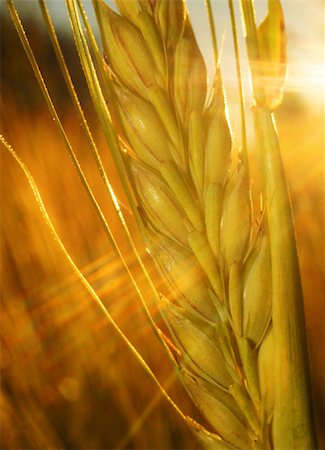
[{"left": 241, "top": 0, "right": 316, "bottom": 450}]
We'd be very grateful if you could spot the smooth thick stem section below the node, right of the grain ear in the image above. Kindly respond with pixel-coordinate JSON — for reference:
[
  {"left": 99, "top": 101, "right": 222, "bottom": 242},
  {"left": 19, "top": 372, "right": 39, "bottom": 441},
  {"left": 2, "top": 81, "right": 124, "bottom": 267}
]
[{"left": 256, "top": 107, "right": 316, "bottom": 450}]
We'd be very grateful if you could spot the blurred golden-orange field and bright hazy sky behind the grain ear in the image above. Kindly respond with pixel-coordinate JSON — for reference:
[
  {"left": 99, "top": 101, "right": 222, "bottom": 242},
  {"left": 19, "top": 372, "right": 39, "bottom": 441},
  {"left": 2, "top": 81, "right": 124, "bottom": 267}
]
[{"left": 0, "top": 0, "right": 325, "bottom": 449}]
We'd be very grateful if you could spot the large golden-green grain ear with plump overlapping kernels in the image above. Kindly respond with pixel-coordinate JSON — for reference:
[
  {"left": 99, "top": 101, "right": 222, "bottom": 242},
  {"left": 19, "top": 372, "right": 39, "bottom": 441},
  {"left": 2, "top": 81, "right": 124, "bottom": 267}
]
[{"left": 95, "top": 1, "right": 273, "bottom": 449}]
